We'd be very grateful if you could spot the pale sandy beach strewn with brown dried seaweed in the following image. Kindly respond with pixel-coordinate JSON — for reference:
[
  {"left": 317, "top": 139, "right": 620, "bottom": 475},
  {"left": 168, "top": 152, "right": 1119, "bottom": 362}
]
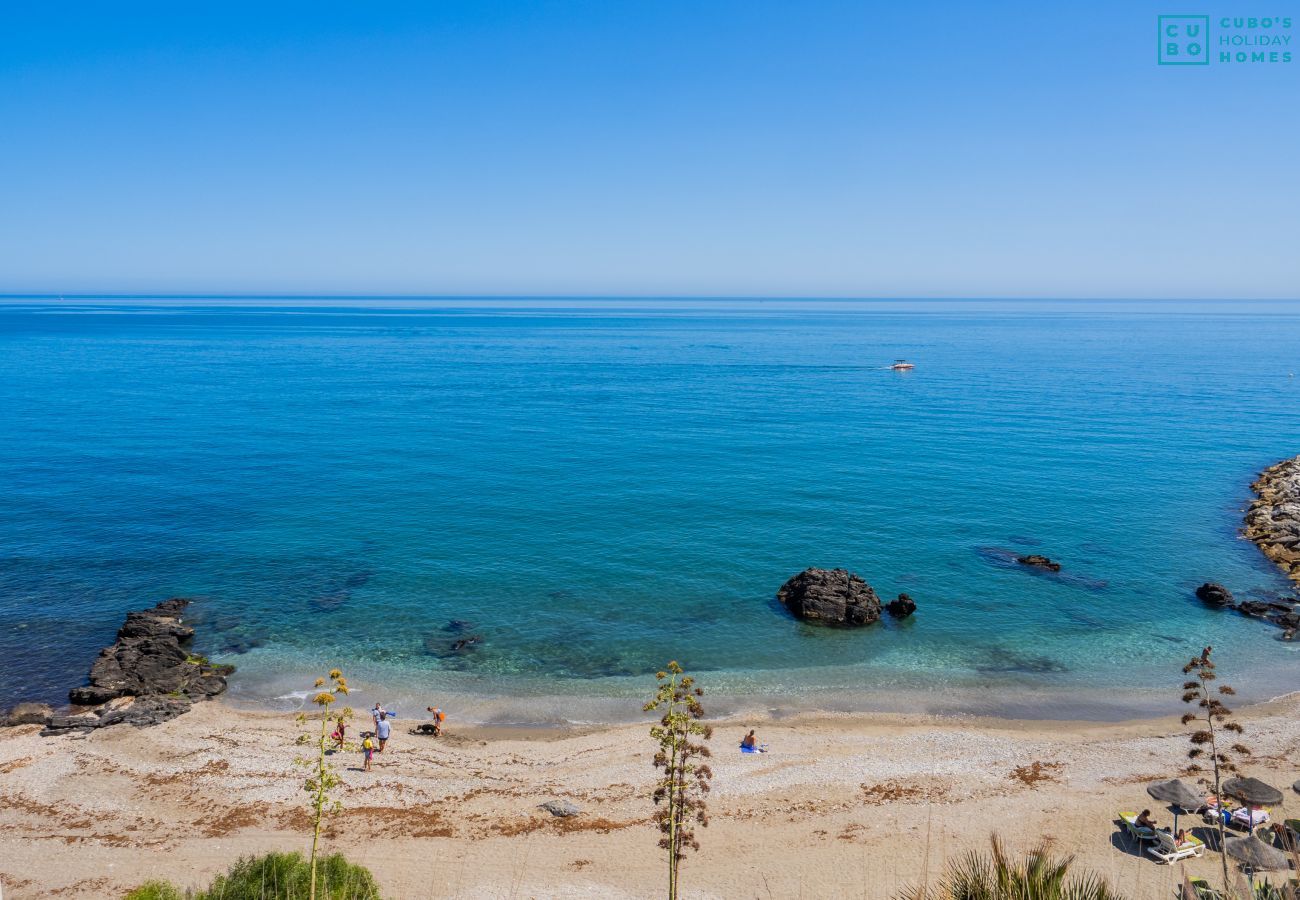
[{"left": 0, "top": 696, "right": 1300, "bottom": 900}]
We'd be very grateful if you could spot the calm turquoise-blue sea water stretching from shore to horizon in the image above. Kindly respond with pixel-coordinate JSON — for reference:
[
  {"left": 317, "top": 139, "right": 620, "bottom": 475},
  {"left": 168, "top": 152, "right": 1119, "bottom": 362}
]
[{"left": 0, "top": 299, "right": 1300, "bottom": 722}]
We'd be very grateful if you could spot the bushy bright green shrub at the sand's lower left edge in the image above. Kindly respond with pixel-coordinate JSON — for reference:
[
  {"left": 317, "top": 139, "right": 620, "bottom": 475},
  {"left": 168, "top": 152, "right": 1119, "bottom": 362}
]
[{"left": 194, "top": 853, "right": 380, "bottom": 900}]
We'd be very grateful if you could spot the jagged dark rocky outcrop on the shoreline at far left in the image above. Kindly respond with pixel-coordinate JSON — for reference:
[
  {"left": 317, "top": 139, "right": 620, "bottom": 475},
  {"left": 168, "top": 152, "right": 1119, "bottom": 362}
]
[{"left": 42, "top": 598, "right": 234, "bottom": 734}]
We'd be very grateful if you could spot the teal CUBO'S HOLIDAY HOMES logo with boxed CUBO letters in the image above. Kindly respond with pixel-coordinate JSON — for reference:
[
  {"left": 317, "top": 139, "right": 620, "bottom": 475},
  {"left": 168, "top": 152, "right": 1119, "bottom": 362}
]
[{"left": 1156, "top": 16, "right": 1292, "bottom": 65}]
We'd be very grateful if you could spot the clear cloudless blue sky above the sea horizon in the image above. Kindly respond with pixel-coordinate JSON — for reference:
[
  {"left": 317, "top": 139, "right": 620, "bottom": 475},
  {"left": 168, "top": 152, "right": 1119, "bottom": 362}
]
[{"left": 0, "top": 0, "right": 1300, "bottom": 298}]
